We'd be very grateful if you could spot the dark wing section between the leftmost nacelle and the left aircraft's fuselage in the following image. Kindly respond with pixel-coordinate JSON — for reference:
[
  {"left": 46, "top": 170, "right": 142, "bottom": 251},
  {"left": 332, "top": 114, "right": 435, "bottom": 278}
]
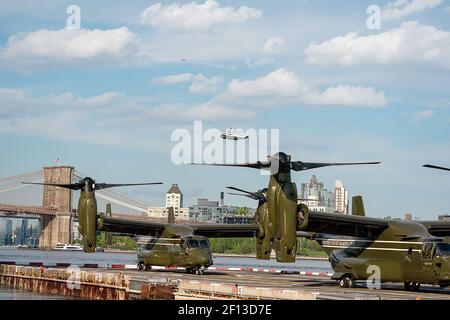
[{"left": 100, "top": 218, "right": 167, "bottom": 235}]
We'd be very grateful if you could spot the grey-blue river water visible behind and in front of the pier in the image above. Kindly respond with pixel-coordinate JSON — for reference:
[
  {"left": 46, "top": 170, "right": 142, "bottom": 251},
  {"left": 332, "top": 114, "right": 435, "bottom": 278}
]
[{"left": 0, "top": 247, "right": 332, "bottom": 300}]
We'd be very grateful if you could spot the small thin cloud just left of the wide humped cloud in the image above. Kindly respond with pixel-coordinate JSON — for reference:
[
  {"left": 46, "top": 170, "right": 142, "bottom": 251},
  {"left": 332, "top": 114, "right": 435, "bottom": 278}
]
[{"left": 154, "top": 73, "right": 222, "bottom": 93}]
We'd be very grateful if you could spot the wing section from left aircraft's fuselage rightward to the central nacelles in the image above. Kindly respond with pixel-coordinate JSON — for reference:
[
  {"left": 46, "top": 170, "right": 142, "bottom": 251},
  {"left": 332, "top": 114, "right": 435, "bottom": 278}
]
[{"left": 190, "top": 224, "right": 258, "bottom": 238}]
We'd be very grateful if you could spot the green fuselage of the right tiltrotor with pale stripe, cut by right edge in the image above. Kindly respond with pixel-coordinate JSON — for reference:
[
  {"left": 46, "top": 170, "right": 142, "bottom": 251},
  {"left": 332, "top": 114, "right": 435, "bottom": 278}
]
[{"left": 315, "top": 221, "right": 450, "bottom": 286}]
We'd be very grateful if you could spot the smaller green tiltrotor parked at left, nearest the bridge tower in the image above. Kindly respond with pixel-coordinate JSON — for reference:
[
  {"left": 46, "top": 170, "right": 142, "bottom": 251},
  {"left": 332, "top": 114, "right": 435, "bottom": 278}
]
[{"left": 23, "top": 177, "right": 258, "bottom": 274}]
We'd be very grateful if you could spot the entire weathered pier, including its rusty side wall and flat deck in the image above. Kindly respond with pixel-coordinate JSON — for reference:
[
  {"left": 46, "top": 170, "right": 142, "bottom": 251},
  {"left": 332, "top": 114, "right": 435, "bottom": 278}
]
[{"left": 0, "top": 265, "right": 450, "bottom": 300}]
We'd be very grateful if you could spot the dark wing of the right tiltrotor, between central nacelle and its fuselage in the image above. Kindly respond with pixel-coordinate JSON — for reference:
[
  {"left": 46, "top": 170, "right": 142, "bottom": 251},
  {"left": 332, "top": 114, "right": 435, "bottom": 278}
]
[{"left": 298, "top": 211, "right": 389, "bottom": 237}]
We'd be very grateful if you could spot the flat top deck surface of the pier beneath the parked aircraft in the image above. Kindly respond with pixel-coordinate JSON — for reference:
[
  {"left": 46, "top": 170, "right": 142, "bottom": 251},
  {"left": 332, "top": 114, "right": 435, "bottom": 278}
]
[{"left": 81, "top": 269, "right": 450, "bottom": 300}]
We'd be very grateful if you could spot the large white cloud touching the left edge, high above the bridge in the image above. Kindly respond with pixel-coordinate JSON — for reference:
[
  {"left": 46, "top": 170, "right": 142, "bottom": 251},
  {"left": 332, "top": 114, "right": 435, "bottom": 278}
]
[{"left": 0, "top": 27, "right": 137, "bottom": 66}]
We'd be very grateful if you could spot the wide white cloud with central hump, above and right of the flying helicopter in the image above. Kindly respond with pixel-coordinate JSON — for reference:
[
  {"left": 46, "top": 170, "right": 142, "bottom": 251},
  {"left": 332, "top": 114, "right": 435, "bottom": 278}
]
[{"left": 218, "top": 68, "right": 387, "bottom": 107}]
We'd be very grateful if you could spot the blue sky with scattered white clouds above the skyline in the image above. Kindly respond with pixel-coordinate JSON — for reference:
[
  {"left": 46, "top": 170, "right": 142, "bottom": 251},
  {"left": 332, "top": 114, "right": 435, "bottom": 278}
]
[{"left": 0, "top": 0, "right": 450, "bottom": 219}]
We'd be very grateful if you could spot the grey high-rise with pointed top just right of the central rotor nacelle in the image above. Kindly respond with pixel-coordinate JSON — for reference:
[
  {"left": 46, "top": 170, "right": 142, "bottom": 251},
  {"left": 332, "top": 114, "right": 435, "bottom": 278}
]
[{"left": 299, "top": 175, "right": 334, "bottom": 213}]
